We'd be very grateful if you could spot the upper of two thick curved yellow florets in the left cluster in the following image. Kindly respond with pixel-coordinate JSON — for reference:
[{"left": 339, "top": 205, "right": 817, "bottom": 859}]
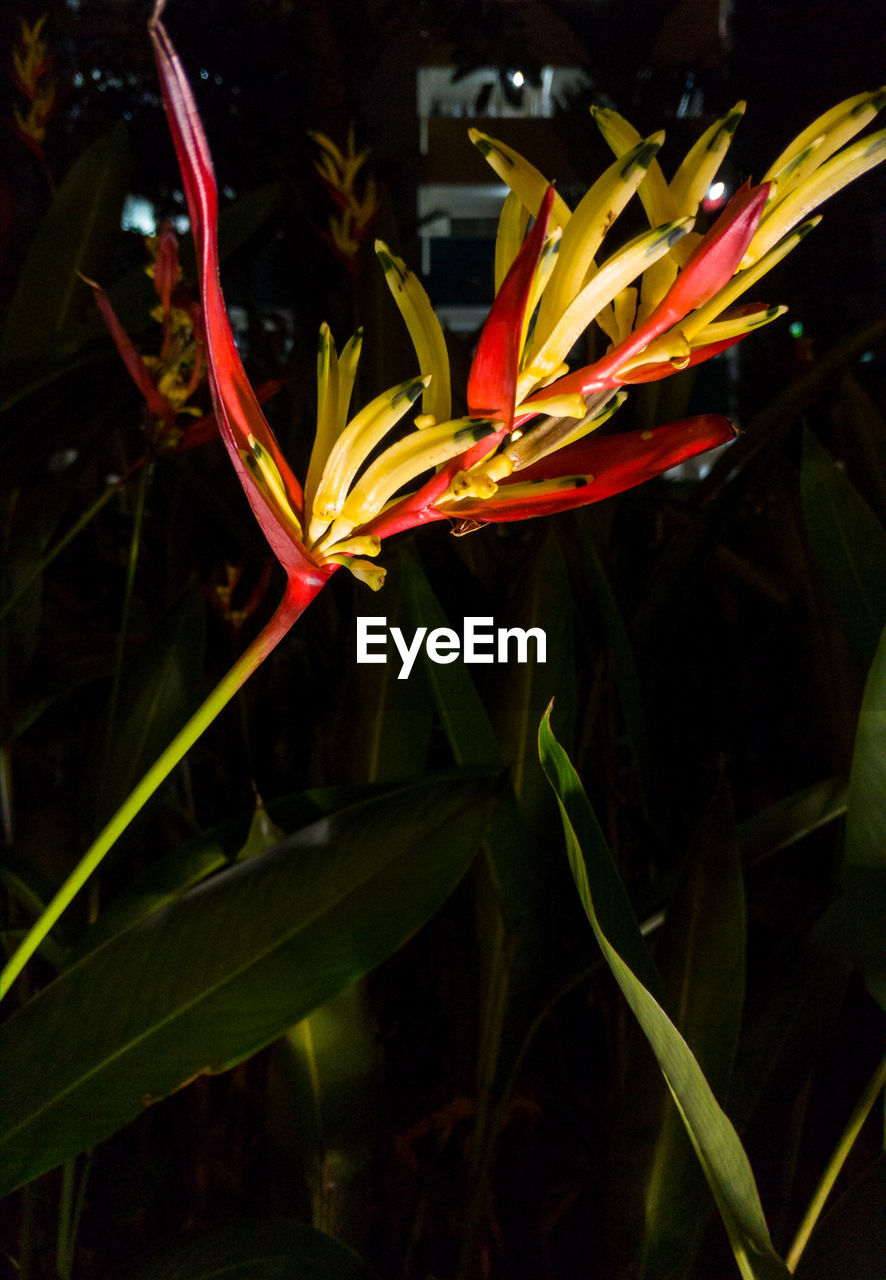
[{"left": 307, "top": 378, "right": 428, "bottom": 544}]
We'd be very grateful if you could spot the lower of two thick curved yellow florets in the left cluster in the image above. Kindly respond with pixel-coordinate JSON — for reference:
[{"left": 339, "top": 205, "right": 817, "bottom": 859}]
[{"left": 319, "top": 417, "right": 501, "bottom": 540}]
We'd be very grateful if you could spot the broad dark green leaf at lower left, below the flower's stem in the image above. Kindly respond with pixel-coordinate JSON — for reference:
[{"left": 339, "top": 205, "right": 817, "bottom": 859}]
[{"left": 0, "top": 780, "right": 490, "bottom": 1190}]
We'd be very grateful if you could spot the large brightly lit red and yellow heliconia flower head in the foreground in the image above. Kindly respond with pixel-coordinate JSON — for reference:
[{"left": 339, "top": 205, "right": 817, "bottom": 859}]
[{"left": 151, "top": 0, "right": 880, "bottom": 623}]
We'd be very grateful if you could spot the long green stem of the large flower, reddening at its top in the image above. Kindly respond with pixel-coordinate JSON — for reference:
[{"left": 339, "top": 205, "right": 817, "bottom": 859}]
[{"left": 0, "top": 572, "right": 329, "bottom": 1000}]
